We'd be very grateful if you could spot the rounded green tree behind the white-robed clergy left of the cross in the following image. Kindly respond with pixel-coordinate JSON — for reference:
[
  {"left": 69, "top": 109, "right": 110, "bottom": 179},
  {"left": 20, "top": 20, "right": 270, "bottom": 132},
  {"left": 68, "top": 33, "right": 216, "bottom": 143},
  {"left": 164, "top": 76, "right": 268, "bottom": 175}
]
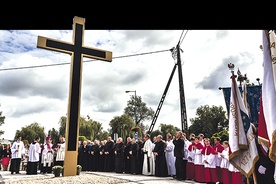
[{"left": 14, "top": 122, "right": 46, "bottom": 143}]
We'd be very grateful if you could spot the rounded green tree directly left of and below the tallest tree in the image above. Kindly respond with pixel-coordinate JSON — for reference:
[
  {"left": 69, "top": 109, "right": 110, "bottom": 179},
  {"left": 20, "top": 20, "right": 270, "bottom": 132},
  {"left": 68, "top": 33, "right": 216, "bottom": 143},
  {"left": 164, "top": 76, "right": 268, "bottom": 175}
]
[{"left": 109, "top": 114, "right": 135, "bottom": 140}]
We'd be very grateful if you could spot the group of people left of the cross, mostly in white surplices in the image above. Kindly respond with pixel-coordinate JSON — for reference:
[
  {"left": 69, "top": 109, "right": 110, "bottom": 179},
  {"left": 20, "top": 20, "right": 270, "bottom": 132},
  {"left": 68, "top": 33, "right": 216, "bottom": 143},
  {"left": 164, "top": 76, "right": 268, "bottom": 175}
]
[{"left": 0, "top": 136, "right": 65, "bottom": 175}]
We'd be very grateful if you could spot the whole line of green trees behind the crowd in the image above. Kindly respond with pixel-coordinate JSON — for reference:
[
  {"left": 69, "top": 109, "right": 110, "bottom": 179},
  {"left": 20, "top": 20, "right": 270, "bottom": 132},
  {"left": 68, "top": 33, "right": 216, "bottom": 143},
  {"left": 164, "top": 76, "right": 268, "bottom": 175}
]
[{"left": 0, "top": 95, "right": 228, "bottom": 144}]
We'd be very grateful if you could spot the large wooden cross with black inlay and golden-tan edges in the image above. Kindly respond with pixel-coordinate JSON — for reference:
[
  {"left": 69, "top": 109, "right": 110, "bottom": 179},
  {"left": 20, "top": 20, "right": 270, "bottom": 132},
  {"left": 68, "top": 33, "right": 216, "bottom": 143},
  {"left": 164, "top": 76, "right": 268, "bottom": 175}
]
[{"left": 37, "top": 16, "right": 112, "bottom": 176}]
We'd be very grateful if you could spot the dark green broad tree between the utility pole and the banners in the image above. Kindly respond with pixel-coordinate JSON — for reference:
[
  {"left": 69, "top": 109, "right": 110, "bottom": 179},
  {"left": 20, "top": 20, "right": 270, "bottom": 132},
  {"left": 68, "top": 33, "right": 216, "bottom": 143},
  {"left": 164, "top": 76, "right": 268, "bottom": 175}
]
[{"left": 189, "top": 105, "right": 228, "bottom": 138}]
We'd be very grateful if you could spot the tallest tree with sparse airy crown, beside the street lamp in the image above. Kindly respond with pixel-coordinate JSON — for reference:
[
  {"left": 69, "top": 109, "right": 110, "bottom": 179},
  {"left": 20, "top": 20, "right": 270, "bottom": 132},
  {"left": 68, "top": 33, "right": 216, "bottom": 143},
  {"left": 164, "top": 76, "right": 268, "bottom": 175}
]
[{"left": 124, "top": 95, "right": 154, "bottom": 131}]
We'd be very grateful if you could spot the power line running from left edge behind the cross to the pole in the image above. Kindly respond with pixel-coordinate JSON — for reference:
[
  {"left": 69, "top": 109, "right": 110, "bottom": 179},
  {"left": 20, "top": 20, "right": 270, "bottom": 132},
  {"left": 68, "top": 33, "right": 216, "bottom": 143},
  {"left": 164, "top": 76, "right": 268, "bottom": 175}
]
[{"left": 0, "top": 49, "right": 170, "bottom": 71}]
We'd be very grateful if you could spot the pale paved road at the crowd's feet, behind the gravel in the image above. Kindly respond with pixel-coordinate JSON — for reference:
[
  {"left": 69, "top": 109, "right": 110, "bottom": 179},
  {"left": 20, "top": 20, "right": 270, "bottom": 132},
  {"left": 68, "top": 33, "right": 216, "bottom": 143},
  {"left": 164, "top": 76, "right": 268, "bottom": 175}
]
[{"left": 0, "top": 171, "right": 203, "bottom": 184}]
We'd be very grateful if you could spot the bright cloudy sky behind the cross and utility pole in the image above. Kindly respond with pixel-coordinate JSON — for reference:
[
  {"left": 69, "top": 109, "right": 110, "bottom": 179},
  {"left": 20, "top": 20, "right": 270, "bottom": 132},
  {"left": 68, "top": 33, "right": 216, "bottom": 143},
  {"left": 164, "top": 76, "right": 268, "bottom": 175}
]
[{"left": 0, "top": 30, "right": 263, "bottom": 139}]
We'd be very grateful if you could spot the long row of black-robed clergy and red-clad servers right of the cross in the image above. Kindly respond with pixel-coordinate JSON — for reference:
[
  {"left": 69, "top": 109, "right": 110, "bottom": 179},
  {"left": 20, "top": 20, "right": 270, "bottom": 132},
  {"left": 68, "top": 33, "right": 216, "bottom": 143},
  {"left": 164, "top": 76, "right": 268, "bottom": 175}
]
[{"left": 75, "top": 131, "right": 244, "bottom": 184}]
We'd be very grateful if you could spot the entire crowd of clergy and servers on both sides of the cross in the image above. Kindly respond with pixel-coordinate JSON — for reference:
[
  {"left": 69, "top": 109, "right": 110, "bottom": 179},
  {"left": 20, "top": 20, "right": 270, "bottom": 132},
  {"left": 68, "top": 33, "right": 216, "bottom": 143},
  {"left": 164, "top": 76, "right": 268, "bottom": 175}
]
[{"left": 0, "top": 131, "right": 275, "bottom": 184}]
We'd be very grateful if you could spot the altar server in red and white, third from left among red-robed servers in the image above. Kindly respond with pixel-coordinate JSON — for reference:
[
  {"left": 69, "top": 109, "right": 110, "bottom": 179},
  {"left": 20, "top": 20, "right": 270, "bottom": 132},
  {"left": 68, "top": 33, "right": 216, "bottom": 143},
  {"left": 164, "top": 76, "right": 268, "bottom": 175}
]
[{"left": 202, "top": 145, "right": 218, "bottom": 182}]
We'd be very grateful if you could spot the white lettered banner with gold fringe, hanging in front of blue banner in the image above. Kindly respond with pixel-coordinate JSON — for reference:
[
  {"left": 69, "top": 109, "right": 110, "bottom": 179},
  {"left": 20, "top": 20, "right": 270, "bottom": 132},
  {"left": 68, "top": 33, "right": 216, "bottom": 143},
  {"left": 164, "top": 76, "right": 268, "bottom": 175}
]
[{"left": 229, "top": 72, "right": 259, "bottom": 178}]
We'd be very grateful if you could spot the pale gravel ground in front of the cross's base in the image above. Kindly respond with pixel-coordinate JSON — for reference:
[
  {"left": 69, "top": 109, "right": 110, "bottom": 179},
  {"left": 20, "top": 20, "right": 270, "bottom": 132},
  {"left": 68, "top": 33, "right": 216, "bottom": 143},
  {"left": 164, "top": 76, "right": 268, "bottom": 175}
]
[{"left": 4, "top": 173, "right": 128, "bottom": 184}]
